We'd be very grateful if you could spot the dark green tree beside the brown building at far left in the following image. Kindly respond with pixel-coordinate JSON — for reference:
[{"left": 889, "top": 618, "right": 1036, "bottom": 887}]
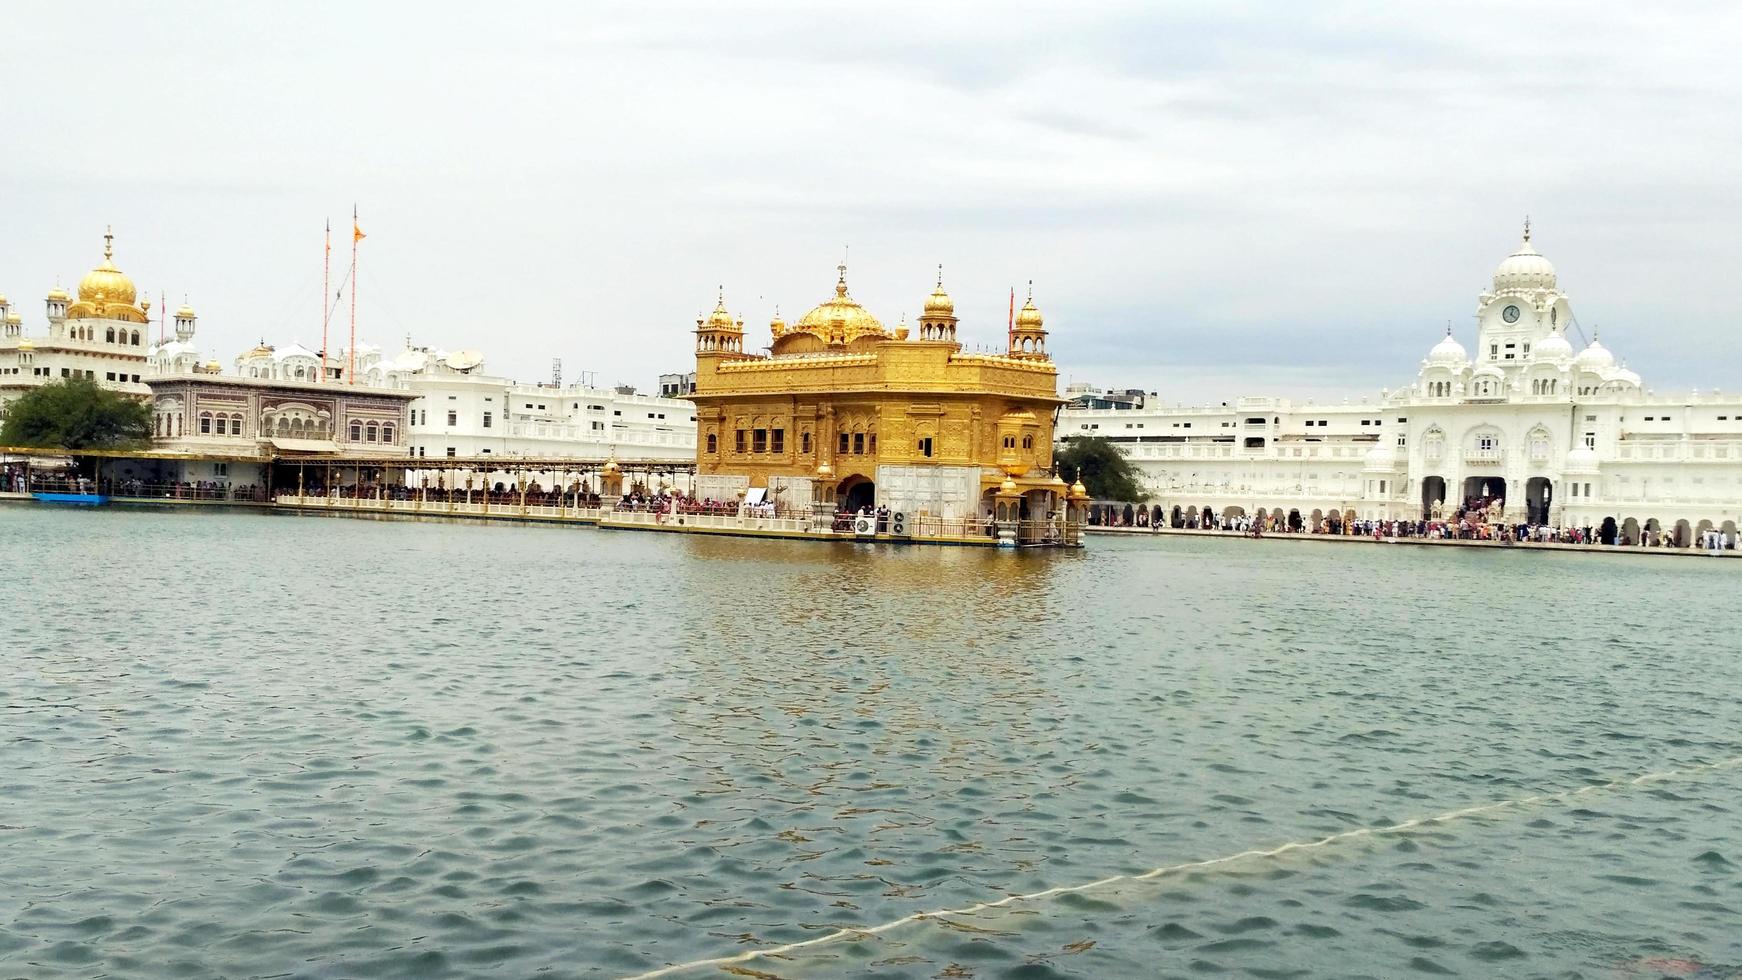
[{"left": 0, "top": 378, "right": 152, "bottom": 449}]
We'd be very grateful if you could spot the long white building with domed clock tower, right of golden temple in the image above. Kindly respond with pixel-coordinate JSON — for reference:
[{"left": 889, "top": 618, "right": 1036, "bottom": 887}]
[{"left": 1057, "top": 225, "right": 1742, "bottom": 547}]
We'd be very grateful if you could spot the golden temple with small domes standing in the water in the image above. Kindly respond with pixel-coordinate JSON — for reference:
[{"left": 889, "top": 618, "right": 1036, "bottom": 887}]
[{"left": 692, "top": 265, "right": 1082, "bottom": 543}]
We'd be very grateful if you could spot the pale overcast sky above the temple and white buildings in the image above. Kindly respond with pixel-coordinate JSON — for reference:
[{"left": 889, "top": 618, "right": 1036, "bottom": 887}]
[{"left": 0, "top": 0, "right": 1742, "bottom": 402}]
